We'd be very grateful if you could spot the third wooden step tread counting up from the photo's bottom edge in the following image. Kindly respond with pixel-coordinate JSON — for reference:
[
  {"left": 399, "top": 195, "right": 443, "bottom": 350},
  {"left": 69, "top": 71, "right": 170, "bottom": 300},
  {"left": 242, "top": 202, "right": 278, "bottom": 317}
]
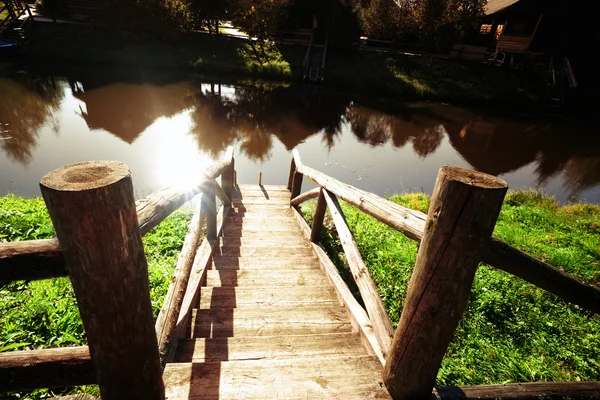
[{"left": 191, "top": 306, "right": 352, "bottom": 338}]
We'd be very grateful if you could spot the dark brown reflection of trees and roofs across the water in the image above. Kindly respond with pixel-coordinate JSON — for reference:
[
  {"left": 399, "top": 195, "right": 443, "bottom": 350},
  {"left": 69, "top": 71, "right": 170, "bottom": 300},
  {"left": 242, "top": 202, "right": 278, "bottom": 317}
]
[{"left": 0, "top": 70, "right": 600, "bottom": 202}]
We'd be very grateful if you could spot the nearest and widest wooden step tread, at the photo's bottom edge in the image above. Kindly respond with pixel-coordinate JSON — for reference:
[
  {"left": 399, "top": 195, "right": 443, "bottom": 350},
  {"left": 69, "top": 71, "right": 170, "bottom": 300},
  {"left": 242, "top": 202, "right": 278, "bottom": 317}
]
[{"left": 164, "top": 356, "right": 390, "bottom": 400}]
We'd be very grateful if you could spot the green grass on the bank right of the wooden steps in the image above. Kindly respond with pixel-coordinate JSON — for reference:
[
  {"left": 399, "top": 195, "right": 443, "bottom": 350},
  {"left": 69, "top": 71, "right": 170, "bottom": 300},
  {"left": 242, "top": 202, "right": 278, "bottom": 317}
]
[{"left": 303, "top": 191, "right": 600, "bottom": 385}]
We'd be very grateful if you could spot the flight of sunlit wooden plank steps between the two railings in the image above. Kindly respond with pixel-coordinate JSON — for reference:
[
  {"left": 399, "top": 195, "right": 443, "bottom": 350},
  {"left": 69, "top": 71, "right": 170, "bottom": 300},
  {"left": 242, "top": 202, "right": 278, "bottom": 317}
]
[{"left": 164, "top": 185, "right": 390, "bottom": 399}]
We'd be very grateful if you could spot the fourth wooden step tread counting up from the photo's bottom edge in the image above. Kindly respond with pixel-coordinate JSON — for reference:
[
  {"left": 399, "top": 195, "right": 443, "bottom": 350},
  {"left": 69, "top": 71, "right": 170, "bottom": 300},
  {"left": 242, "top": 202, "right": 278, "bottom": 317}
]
[{"left": 199, "top": 282, "right": 340, "bottom": 310}]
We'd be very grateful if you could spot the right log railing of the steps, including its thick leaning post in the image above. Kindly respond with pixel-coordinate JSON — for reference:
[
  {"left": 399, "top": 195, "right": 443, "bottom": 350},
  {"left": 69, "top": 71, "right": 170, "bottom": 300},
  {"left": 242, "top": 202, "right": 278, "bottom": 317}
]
[{"left": 288, "top": 150, "right": 600, "bottom": 399}]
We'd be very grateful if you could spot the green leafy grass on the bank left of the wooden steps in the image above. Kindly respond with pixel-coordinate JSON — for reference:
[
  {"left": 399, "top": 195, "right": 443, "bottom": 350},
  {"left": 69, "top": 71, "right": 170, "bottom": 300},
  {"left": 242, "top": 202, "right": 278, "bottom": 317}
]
[{"left": 0, "top": 194, "right": 192, "bottom": 399}]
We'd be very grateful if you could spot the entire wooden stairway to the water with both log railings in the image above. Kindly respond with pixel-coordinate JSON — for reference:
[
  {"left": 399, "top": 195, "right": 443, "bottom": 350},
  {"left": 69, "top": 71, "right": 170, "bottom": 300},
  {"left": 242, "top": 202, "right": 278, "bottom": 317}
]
[{"left": 0, "top": 149, "right": 600, "bottom": 400}]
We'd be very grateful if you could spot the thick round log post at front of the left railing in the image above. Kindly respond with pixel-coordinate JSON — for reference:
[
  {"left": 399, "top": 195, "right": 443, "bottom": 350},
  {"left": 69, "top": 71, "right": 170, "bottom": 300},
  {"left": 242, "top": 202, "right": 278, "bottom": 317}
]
[{"left": 40, "top": 161, "right": 165, "bottom": 400}]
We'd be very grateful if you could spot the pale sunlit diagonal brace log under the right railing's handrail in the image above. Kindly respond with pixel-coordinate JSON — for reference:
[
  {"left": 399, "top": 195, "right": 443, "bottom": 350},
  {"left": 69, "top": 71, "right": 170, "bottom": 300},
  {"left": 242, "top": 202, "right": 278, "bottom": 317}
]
[{"left": 323, "top": 190, "right": 394, "bottom": 357}]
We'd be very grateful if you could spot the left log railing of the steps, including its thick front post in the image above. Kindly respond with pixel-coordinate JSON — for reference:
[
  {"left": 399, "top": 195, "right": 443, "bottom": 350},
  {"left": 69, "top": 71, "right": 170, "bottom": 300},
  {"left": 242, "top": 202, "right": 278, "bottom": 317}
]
[{"left": 0, "top": 148, "right": 235, "bottom": 400}]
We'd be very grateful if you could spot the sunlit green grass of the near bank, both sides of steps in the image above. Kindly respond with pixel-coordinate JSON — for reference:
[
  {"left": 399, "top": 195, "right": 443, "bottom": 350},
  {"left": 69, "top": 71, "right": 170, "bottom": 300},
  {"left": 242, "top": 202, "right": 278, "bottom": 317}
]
[{"left": 0, "top": 191, "right": 600, "bottom": 398}]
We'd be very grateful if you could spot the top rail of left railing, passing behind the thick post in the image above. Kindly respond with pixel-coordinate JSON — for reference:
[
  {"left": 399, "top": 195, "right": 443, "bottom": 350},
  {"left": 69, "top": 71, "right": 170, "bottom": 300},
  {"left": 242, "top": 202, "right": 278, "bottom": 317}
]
[{"left": 0, "top": 148, "right": 233, "bottom": 282}]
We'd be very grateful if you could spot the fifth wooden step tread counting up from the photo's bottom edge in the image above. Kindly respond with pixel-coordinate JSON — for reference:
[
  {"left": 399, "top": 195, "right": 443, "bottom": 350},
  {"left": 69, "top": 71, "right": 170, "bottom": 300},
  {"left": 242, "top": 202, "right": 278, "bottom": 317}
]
[{"left": 206, "top": 269, "right": 329, "bottom": 287}]
